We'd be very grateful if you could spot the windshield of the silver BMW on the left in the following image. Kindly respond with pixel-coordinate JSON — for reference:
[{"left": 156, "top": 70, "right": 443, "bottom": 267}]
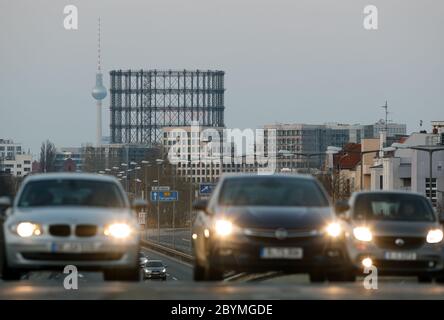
[{"left": 18, "top": 179, "right": 125, "bottom": 208}]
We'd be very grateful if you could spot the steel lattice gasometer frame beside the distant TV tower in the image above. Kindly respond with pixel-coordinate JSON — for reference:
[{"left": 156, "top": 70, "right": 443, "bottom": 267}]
[{"left": 110, "top": 70, "right": 225, "bottom": 145}]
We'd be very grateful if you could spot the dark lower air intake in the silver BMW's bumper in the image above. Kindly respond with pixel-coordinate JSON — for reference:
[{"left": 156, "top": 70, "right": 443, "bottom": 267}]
[{"left": 22, "top": 252, "right": 123, "bottom": 261}]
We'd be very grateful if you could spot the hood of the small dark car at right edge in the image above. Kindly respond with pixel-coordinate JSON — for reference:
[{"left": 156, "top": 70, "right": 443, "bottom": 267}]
[{"left": 353, "top": 220, "right": 441, "bottom": 237}]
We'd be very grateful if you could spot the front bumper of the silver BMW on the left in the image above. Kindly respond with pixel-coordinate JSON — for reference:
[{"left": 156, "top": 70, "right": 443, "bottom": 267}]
[{"left": 6, "top": 237, "right": 139, "bottom": 270}]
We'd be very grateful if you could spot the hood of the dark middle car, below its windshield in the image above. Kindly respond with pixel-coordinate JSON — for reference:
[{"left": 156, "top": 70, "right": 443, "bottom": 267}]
[{"left": 217, "top": 206, "right": 334, "bottom": 230}]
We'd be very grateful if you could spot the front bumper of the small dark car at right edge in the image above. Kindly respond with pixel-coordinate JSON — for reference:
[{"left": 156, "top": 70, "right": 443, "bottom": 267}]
[{"left": 347, "top": 243, "right": 444, "bottom": 275}]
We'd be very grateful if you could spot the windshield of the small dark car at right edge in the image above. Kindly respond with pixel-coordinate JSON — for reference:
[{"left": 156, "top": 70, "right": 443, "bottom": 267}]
[{"left": 354, "top": 194, "right": 436, "bottom": 222}]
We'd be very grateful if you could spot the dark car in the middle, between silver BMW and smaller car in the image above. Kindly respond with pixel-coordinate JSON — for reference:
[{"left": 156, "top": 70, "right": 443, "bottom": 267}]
[{"left": 192, "top": 175, "right": 354, "bottom": 282}]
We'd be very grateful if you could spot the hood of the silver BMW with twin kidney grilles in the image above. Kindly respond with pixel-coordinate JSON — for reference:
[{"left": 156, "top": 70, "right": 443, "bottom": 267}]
[{"left": 7, "top": 207, "right": 135, "bottom": 225}]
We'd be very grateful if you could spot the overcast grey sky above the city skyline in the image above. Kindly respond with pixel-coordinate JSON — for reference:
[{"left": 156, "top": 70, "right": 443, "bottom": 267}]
[{"left": 0, "top": 0, "right": 444, "bottom": 153}]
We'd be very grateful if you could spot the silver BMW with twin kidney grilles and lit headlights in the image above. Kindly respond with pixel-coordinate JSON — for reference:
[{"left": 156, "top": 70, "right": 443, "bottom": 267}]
[{"left": 0, "top": 173, "right": 143, "bottom": 281}]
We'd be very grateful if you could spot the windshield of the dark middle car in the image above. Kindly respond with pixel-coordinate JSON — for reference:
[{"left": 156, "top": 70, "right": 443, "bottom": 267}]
[{"left": 219, "top": 177, "right": 329, "bottom": 207}]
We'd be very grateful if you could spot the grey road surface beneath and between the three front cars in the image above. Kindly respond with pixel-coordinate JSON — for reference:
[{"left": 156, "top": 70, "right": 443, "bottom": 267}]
[{"left": 0, "top": 248, "right": 444, "bottom": 300}]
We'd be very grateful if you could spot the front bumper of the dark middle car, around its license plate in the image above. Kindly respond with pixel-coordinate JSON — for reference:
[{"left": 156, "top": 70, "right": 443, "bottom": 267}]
[{"left": 206, "top": 237, "right": 348, "bottom": 273}]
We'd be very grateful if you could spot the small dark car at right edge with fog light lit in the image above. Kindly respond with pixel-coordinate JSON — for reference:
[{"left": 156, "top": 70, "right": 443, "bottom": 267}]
[{"left": 336, "top": 191, "right": 443, "bottom": 282}]
